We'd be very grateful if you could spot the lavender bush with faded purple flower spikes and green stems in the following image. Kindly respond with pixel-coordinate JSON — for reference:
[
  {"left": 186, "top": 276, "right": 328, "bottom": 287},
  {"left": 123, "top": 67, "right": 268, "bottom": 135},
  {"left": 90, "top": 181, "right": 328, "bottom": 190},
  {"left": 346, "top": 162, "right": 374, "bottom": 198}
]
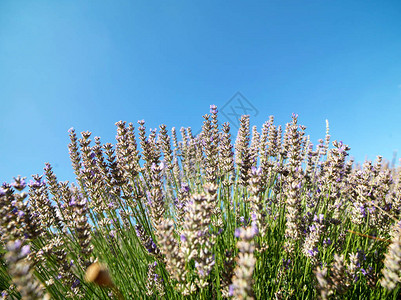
[{"left": 0, "top": 105, "right": 401, "bottom": 299}]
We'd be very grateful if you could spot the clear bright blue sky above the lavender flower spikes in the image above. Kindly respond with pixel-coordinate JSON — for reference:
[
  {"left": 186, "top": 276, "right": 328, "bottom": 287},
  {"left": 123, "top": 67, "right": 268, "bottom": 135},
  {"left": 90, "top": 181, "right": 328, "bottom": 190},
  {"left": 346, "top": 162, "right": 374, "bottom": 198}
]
[{"left": 0, "top": 0, "right": 401, "bottom": 181}]
